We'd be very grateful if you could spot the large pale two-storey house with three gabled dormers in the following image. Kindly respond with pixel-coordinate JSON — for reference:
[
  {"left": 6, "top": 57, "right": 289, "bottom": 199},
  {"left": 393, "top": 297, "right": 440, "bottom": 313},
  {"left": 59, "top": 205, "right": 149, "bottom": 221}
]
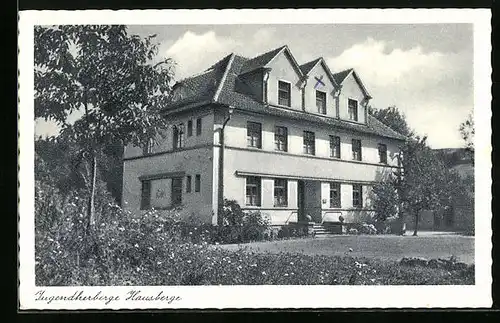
[{"left": 122, "top": 46, "right": 405, "bottom": 225}]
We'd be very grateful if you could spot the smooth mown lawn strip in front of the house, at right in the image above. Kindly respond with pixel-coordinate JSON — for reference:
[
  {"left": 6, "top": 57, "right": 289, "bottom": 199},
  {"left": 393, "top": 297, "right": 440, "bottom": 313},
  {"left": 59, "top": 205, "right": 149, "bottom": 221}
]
[{"left": 221, "top": 233, "right": 474, "bottom": 264}]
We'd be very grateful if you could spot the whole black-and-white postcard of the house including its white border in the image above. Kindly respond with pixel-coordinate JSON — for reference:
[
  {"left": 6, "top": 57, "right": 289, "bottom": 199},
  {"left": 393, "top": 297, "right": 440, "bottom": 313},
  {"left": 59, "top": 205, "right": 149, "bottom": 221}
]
[{"left": 19, "top": 9, "right": 491, "bottom": 309}]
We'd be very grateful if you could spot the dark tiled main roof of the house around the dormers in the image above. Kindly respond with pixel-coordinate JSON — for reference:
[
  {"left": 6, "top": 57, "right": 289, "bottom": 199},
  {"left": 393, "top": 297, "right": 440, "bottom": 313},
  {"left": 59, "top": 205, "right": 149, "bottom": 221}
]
[{"left": 164, "top": 48, "right": 405, "bottom": 140}]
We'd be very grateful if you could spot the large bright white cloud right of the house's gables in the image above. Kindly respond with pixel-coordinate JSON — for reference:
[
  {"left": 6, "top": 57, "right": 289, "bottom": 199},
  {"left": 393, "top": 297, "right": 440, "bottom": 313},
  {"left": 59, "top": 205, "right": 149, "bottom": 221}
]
[{"left": 327, "top": 38, "right": 473, "bottom": 148}]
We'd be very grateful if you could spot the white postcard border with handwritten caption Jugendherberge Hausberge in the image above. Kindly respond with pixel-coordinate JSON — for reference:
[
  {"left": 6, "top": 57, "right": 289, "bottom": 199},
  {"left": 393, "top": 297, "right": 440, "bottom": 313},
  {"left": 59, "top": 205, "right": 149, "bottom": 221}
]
[{"left": 18, "top": 9, "right": 492, "bottom": 309}]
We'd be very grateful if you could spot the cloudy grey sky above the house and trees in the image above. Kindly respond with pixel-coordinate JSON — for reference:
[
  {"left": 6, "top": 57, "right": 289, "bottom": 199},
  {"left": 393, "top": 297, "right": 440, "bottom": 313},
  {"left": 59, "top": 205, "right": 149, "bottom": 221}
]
[{"left": 35, "top": 24, "right": 474, "bottom": 148}]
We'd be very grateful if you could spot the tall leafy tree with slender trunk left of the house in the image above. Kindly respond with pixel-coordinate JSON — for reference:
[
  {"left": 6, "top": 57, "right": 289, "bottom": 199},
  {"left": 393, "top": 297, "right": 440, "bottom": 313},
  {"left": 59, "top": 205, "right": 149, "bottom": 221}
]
[{"left": 34, "top": 25, "right": 173, "bottom": 233}]
